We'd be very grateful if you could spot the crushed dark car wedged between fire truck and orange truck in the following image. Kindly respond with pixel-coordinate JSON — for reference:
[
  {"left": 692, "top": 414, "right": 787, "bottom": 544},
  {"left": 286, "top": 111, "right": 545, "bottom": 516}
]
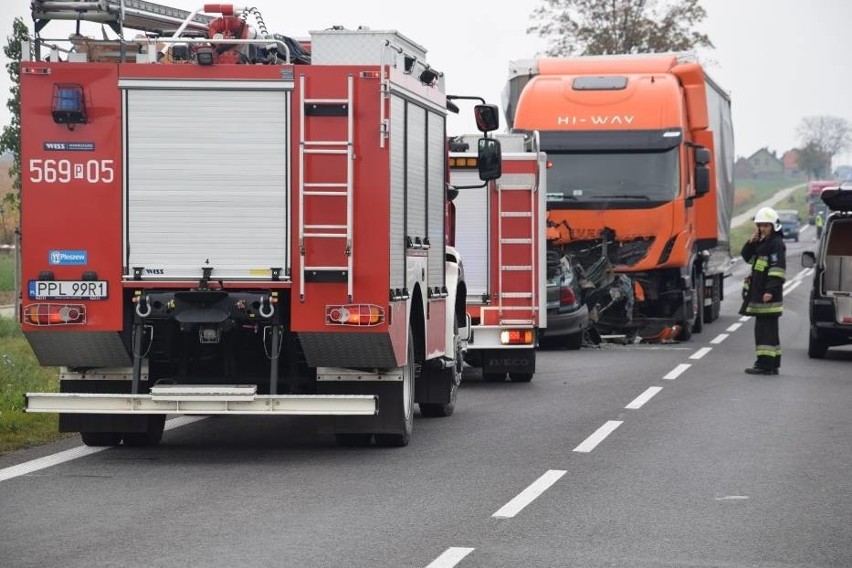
[{"left": 539, "top": 251, "right": 589, "bottom": 349}]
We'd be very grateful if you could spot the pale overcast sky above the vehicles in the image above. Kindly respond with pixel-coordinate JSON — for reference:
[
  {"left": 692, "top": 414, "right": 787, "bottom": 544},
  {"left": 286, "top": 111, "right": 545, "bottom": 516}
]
[{"left": 0, "top": 0, "right": 852, "bottom": 166}]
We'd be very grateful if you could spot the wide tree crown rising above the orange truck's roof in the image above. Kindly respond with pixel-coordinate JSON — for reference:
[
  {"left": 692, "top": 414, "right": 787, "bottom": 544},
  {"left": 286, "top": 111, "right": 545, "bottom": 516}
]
[{"left": 527, "top": 0, "right": 713, "bottom": 57}]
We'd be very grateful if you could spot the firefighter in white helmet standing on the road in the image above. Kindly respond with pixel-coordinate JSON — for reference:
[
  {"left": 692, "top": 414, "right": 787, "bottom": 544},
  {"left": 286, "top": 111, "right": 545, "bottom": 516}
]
[{"left": 740, "top": 207, "right": 787, "bottom": 375}]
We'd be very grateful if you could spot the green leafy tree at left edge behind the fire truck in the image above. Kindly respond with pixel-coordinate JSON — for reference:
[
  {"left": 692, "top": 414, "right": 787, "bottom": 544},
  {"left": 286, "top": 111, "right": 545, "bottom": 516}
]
[{"left": 0, "top": 18, "right": 29, "bottom": 213}]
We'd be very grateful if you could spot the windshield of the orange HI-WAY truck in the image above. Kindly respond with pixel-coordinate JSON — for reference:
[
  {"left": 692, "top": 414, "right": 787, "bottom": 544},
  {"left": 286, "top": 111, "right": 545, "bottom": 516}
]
[{"left": 547, "top": 147, "right": 680, "bottom": 202}]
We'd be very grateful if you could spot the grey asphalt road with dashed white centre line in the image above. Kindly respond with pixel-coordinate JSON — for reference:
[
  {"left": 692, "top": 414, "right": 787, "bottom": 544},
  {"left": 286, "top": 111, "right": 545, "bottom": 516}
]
[{"left": 0, "top": 224, "right": 852, "bottom": 568}]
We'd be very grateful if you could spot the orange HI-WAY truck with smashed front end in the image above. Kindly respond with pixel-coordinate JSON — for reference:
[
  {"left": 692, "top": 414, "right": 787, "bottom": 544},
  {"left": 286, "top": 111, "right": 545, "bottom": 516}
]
[{"left": 503, "top": 54, "right": 734, "bottom": 339}]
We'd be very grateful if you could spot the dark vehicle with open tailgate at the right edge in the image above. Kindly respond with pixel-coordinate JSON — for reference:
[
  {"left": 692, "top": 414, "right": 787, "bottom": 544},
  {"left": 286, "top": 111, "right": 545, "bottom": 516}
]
[{"left": 802, "top": 186, "right": 852, "bottom": 359}]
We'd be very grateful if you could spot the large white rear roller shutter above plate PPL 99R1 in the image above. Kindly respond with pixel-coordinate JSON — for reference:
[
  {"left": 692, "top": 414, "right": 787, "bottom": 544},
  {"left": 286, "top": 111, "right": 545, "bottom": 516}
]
[{"left": 125, "top": 84, "right": 289, "bottom": 279}]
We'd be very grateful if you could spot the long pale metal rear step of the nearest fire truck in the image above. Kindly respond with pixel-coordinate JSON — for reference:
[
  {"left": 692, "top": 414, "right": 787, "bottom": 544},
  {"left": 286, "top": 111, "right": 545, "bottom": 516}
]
[{"left": 26, "top": 385, "right": 378, "bottom": 416}]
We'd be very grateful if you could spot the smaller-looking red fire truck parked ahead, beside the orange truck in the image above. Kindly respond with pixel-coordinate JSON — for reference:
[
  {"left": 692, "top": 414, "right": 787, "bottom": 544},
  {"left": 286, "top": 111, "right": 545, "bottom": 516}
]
[{"left": 450, "top": 134, "right": 547, "bottom": 382}]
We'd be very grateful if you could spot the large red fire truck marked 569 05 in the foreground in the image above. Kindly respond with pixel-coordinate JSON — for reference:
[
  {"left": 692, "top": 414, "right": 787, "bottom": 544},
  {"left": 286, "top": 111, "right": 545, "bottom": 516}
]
[{"left": 20, "top": 0, "right": 501, "bottom": 446}]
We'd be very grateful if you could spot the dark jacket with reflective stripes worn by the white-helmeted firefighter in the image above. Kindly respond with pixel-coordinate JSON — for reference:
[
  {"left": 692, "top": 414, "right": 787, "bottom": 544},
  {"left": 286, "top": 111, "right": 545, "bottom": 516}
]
[{"left": 740, "top": 231, "right": 787, "bottom": 316}]
